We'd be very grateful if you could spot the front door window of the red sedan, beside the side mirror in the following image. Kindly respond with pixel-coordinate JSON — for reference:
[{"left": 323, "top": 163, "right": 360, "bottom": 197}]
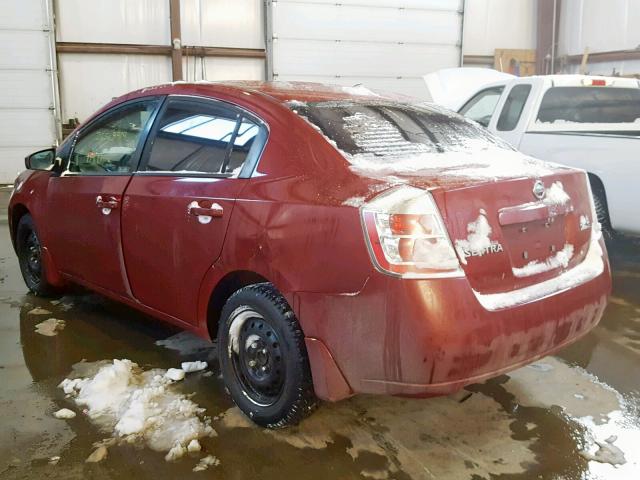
[{"left": 69, "top": 99, "right": 158, "bottom": 175}]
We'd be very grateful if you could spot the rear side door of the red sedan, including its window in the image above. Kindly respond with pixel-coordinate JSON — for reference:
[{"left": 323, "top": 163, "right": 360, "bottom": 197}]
[{"left": 122, "top": 96, "right": 266, "bottom": 323}]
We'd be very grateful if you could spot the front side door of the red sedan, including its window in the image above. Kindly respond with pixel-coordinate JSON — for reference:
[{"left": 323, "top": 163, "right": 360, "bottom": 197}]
[{"left": 46, "top": 98, "right": 160, "bottom": 295}]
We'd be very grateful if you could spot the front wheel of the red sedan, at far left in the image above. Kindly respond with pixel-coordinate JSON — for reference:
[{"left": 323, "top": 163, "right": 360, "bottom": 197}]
[{"left": 16, "top": 213, "right": 56, "bottom": 297}]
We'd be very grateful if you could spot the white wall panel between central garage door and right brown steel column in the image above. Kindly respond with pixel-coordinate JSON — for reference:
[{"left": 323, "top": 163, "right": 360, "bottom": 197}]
[{"left": 462, "top": 0, "right": 536, "bottom": 56}]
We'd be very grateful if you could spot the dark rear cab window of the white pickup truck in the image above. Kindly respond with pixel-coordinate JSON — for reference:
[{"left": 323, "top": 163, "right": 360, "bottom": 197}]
[{"left": 538, "top": 87, "right": 640, "bottom": 123}]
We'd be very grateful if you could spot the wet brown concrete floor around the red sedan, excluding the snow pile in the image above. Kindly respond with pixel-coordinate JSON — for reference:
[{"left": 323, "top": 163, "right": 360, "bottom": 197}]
[{"left": 0, "top": 190, "right": 640, "bottom": 480}]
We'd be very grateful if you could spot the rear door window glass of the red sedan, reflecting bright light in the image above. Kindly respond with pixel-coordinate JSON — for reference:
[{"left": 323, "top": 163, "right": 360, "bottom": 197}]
[{"left": 146, "top": 100, "right": 261, "bottom": 174}]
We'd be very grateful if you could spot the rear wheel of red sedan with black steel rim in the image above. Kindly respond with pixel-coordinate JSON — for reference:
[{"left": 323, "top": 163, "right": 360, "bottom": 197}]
[{"left": 218, "top": 283, "right": 317, "bottom": 428}]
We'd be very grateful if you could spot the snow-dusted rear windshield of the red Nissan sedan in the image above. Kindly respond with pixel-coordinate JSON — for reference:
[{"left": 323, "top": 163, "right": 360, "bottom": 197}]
[{"left": 289, "top": 102, "right": 511, "bottom": 160}]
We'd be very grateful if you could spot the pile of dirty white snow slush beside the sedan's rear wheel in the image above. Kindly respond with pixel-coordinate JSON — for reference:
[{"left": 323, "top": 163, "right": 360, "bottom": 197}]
[{"left": 59, "top": 359, "right": 216, "bottom": 461}]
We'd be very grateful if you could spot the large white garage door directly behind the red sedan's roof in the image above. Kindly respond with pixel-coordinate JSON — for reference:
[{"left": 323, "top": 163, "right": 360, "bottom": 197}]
[{"left": 269, "top": 0, "right": 462, "bottom": 98}]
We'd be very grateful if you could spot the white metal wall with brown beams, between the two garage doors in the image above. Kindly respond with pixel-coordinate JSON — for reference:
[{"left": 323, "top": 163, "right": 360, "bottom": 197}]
[{"left": 56, "top": 0, "right": 264, "bottom": 121}]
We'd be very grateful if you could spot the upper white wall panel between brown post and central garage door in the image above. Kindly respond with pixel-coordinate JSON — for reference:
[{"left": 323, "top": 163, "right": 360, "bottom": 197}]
[{"left": 180, "top": 0, "right": 264, "bottom": 48}]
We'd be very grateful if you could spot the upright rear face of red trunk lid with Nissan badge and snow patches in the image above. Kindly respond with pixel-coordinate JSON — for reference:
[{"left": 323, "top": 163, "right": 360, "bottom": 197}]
[{"left": 434, "top": 171, "right": 594, "bottom": 294}]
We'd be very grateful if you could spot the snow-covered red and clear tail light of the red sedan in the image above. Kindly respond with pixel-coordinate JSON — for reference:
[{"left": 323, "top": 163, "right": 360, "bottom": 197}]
[{"left": 361, "top": 186, "right": 464, "bottom": 278}]
